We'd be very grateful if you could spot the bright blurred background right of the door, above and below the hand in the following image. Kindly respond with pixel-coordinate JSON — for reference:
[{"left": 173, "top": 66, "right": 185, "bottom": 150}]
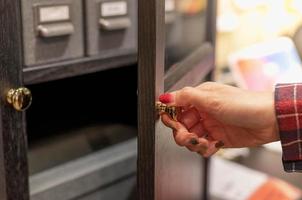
[{"left": 210, "top": 0, "right": 302, "bottom": 199}]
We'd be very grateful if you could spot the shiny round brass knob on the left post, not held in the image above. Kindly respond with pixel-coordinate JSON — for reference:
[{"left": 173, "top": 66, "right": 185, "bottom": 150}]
[{"left": 6, "top": 87, "right": 32, "bottom": 111}]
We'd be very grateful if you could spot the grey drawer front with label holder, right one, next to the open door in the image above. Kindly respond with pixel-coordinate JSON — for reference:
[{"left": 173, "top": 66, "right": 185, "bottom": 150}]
[{"left": 85, "top": 0, "right": 137, "bottom": 57}]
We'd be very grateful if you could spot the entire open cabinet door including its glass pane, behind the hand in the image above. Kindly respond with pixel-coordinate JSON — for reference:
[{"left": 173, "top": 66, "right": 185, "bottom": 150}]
[{"left": 138, "top": 0, "right": 216, "bottom": 200}]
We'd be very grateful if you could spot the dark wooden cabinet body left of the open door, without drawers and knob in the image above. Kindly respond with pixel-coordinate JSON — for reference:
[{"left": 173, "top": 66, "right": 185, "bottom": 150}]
[{"left": 0, "top": 0, "right": 137, "bottom": 200}]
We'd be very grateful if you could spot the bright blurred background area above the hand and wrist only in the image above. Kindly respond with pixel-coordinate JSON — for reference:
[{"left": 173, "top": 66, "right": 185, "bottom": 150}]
[{"left": 216, "top": 0, "right": 302, "bottom": 90}]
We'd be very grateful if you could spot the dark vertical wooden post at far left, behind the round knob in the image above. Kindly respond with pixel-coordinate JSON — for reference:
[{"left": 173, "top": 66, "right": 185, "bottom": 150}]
[{"left": 0, "top": 0, "right": 29, "bottom": 200}]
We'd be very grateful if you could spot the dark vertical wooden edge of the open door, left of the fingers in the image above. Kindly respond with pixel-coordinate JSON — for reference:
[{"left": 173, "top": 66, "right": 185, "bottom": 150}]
[{"left": 137, "top": 0, "right": 165, "bottom": 200}]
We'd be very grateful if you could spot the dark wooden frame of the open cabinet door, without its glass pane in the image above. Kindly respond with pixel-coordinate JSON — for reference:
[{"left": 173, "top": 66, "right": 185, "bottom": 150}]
[{"left": 138, "top": 0, "right": 216, "bottom": 200}]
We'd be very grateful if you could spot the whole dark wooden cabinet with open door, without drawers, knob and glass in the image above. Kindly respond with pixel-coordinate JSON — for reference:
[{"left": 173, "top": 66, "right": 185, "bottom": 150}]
[{"left": 0, "top": 0, "right": 216, "bottom": 200}]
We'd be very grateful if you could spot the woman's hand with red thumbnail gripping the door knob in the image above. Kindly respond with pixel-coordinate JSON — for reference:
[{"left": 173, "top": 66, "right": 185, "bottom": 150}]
[{"left": 160, "top": 82, "right": 279, "bottom": 157}]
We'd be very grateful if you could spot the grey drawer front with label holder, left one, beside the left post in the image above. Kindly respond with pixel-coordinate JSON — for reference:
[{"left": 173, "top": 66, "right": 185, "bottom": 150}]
[{"left": 22, "top": 0, "right": 84, "bottom": 66}]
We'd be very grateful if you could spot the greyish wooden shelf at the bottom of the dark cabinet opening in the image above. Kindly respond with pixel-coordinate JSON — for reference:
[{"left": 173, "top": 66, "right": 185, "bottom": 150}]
[{"left": 29, "top": 138, "right": 137, "bottom": 200}]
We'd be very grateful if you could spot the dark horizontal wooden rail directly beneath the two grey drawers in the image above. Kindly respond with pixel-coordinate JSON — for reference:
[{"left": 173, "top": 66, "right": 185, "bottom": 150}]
[{"left": 23, "top": 52, "right": 137, "bottom": 84}]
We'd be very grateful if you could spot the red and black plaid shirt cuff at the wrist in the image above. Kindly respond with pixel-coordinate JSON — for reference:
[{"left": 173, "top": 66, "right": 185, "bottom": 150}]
[{"left": 275, "top": 84, "right": 302, "bottom": 172}]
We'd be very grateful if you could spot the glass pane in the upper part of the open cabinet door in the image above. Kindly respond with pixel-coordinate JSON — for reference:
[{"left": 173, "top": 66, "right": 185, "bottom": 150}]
[{"left": 165, "top": 0, "right": 207, "bottom": 70}]
